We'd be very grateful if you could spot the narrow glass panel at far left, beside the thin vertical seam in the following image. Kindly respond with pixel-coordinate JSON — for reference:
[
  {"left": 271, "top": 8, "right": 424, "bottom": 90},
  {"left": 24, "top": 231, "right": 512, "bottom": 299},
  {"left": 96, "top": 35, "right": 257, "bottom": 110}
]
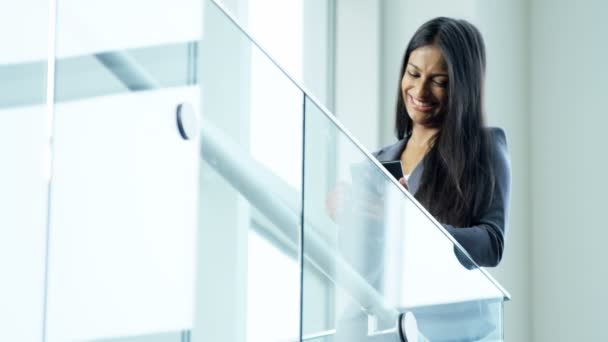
[{"left": 0, "top": 0, "right": 49, "bottom": 342}]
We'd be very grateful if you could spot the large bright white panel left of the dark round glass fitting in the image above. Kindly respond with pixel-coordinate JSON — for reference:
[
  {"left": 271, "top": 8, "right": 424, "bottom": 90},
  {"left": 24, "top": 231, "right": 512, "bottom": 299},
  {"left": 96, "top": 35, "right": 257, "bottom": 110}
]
[{"left": 47, "top": 89, "right": 199, "bottom": 341}]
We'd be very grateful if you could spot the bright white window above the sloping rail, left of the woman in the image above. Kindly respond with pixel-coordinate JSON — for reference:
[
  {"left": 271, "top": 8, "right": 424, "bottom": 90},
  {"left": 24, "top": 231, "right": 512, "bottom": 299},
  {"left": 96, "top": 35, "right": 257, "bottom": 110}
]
[{"left": 214, "top": 0, "right": 335, "bottom": 109}]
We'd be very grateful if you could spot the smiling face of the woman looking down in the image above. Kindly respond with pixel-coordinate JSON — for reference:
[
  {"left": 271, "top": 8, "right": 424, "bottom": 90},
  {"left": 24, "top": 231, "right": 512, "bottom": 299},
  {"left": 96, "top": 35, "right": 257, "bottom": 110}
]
[{"left": 401, "top": 45, "right": 448, "bottom": 124}]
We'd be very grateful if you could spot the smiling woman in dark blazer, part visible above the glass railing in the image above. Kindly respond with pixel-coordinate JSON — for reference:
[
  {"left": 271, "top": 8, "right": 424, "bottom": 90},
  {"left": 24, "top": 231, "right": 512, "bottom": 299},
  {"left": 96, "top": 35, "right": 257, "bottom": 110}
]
[{"left": 375, "top": 17, "right": 510, "bottom": 266}]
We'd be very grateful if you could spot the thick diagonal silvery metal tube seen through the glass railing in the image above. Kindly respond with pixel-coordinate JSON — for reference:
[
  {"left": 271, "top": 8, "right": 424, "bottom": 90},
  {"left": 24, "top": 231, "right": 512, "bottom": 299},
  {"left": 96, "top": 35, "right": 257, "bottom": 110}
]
[{"left": 95, "top": 48, "right": 399, "bottom": 320}]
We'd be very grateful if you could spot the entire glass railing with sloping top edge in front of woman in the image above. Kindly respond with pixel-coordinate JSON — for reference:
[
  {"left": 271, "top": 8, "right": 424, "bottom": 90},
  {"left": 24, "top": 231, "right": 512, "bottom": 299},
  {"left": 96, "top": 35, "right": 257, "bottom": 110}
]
[{"left": 0, "top": 0, "right": 509, "bottom": 342}]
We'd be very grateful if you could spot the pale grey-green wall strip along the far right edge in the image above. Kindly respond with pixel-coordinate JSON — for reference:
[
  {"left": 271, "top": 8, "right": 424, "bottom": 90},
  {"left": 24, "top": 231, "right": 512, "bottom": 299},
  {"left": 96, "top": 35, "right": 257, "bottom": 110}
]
[{"left": 530, "top": 0, "right": 608, "bottom": 341}]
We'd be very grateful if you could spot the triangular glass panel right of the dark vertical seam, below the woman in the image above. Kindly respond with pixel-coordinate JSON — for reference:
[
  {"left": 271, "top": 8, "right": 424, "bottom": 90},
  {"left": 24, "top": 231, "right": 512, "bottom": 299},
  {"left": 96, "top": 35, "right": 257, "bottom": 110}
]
[{"left": 302, "top": 99, "right": 505, "bottom": 341}]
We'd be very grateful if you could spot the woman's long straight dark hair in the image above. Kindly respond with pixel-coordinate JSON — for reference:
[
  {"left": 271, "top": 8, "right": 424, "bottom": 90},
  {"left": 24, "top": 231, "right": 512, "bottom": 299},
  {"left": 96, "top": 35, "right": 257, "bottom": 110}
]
[{"left": 395, "top": 17, "right": 495, "bottom": 226}]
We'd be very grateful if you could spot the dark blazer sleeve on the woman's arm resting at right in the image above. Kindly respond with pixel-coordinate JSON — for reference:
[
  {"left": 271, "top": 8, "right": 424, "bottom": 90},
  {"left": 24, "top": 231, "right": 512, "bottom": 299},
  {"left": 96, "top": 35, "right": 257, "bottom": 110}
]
[{"left": 443, "top": 128, "right": 511, "bottom": 268}]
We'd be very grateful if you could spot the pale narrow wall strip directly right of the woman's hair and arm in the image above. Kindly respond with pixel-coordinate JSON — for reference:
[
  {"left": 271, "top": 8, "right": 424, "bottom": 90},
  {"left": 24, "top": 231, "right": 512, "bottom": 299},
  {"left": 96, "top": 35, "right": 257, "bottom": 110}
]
[{"left": 474, "top": 1, "right": 537, "bottom": 342}]
